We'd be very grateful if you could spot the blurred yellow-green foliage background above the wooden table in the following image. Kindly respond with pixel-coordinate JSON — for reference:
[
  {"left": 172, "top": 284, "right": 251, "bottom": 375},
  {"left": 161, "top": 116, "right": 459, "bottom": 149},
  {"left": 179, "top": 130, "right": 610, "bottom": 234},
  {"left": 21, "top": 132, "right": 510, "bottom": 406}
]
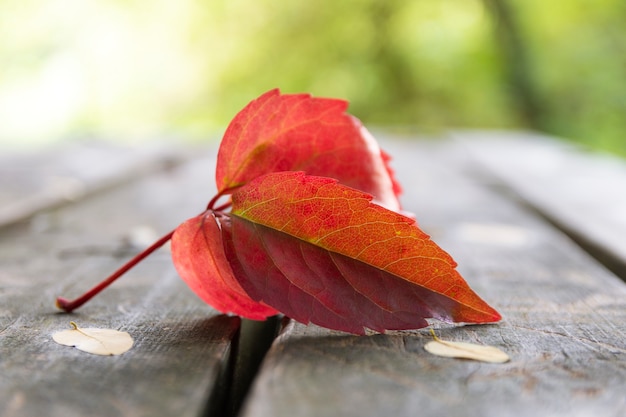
[{"left": 0, "top": 0, "right": 626, "bottom": 155}]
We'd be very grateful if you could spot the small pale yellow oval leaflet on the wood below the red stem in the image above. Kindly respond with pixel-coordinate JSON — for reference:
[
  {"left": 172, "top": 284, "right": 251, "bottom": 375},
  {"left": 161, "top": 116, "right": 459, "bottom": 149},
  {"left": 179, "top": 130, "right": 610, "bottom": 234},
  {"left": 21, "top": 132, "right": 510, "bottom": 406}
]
[{"left": 52, "top": 321, "right": 134, "bottom": 356}]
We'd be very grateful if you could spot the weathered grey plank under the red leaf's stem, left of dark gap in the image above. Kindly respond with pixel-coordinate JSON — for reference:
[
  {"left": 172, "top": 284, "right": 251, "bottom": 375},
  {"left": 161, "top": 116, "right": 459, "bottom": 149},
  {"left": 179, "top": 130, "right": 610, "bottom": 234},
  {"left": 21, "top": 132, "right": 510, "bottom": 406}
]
[{"left": 0, "top": 144, "right": 239, "bottom": 417}]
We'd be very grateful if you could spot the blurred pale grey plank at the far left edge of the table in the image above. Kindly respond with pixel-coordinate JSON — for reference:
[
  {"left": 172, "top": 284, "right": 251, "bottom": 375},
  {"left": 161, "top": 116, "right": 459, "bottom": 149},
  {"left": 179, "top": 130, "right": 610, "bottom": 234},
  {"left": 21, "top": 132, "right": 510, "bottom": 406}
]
[{"left": 0, "top": 142, "right": 184, "bottom": 227}]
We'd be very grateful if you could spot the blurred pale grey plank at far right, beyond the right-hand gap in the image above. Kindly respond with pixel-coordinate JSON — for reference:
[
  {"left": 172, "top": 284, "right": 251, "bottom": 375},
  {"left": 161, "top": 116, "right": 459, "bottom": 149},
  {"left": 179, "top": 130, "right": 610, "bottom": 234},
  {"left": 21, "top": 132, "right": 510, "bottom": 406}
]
[{"left": 454, "top": 132, "right": 626, "bottom": 279}]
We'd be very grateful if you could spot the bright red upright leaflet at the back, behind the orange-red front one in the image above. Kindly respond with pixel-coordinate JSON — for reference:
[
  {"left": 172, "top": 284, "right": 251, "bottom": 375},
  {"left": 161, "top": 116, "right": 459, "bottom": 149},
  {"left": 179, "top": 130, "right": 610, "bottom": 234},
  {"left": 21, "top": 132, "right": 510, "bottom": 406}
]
[{"left": 216, "top": 90, "right": 400, "bottom": 210}]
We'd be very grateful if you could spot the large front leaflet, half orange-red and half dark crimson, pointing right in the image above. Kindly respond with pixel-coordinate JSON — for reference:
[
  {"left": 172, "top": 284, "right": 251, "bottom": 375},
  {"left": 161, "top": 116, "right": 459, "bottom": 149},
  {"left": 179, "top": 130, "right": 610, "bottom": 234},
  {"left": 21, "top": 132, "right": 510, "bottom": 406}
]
[{"left": 227, "top": 172, "right": 500, "bottom": 334}]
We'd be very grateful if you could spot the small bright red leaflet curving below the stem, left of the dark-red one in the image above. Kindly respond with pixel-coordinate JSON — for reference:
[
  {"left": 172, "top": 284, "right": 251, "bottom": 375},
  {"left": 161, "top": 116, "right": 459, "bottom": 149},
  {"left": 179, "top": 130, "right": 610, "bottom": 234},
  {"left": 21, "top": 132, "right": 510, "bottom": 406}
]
[{"left": 172, "top": 211, "right": 278, "bottom": 320}]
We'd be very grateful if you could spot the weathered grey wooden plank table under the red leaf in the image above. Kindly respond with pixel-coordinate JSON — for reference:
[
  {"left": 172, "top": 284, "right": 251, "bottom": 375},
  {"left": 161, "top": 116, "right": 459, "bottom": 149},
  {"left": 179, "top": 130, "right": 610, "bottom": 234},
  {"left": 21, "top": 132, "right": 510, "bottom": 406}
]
[{"left": 0, "top": 132, "right": 626, "bottom": 417}]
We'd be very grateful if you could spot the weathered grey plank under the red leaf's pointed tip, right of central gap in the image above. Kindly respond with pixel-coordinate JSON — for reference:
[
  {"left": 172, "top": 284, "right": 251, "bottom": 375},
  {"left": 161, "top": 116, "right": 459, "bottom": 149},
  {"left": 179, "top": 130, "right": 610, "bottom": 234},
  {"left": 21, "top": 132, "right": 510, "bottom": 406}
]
[{"left": 238, "top": 135, "right": 626, "bottom": 417}]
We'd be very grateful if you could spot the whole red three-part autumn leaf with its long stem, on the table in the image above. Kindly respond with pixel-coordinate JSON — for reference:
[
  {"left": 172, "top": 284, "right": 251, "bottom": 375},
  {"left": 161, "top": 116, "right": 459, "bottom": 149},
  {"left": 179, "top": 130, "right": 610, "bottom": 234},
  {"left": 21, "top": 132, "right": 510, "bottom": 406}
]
[{"left": 57, "top": 90, "right": 500, "bottom": 334}]
